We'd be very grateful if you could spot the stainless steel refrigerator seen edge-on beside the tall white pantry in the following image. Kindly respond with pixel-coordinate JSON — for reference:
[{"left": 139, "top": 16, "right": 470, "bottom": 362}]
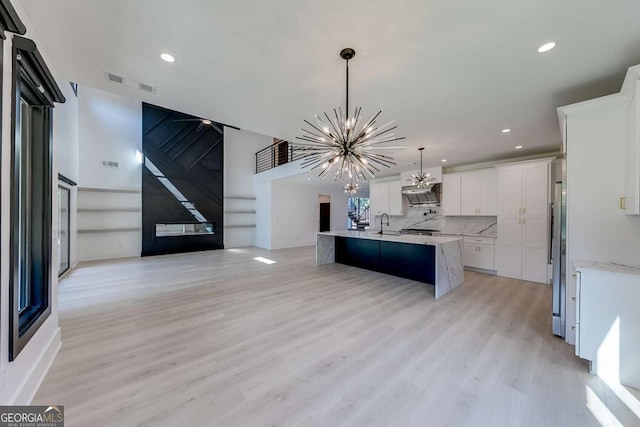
[{"left": 551, "top": 178, "right": 567, "bottom": 337}]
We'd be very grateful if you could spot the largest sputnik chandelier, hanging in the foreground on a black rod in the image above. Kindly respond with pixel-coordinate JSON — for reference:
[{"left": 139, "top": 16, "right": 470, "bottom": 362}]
[{"left": 296, "top": 48, "right": 405, "bottom": 182}]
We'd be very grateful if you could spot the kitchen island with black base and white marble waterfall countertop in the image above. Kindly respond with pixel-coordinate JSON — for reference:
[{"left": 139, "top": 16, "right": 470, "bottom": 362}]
[{"left": 316, "top": 231, "right": 464, "bottom": 298}]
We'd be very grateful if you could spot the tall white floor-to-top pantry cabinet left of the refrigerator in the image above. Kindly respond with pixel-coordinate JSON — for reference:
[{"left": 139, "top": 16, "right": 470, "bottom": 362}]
[{"left": 496, "top": 159, "right": 553, "bottom": 283}]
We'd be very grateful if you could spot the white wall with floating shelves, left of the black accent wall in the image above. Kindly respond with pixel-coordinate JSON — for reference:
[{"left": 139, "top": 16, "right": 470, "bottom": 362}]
[{"left": 77, "top": 86, "right": 142, "bottom": 261}]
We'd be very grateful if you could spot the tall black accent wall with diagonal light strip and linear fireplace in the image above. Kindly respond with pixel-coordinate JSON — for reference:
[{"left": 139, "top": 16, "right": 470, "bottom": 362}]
[{"left": 142, "top": 103, "right": 224, "bottom": 256}]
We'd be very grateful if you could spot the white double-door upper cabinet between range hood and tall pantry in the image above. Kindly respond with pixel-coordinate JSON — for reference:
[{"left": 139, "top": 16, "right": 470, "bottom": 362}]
[{"left": 442, "top": 168, "right": 498, "bottom": 216}]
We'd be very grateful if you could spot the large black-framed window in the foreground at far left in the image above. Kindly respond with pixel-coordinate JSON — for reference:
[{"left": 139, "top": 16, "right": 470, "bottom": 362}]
[{"left": 9, "top": 36, "right": 65, "bottom": 361}]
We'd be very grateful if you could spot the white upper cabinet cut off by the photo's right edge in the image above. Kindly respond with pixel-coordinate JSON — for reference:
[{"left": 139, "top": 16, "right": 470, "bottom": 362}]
[{"left": 621, "top": 66, "right": 640, "bottom": 215}]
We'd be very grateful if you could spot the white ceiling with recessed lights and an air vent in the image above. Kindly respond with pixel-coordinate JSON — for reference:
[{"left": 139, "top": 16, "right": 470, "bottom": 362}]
[{"left": 22, "top": 0, "right": 640, "bottom": 174}]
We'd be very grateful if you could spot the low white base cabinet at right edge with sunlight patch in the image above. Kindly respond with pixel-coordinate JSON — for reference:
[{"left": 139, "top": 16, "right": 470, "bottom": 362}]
[{"left": 576, "top": 262, "right": 640, "bottom": 388}]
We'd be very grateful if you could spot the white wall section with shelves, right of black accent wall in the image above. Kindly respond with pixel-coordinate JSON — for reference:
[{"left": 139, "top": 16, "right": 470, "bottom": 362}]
[{"left": 224, "top": 127, "right": 273, "bottom": 248}]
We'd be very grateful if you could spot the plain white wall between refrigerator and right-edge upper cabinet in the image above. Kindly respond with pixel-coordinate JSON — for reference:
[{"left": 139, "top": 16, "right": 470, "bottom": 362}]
[{"left": 566, "top": 95, "right": 640, "bottom": 343}]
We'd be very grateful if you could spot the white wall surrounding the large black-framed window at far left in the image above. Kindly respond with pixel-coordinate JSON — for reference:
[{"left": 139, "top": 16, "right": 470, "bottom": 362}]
[{"left": 0, "top": 0, "right": 66, "bottom": 405}]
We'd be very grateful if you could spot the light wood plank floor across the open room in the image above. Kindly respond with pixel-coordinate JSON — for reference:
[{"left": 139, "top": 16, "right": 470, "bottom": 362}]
[{"left": 34, "top": 247, "right": 640, "bottom": 427}]
